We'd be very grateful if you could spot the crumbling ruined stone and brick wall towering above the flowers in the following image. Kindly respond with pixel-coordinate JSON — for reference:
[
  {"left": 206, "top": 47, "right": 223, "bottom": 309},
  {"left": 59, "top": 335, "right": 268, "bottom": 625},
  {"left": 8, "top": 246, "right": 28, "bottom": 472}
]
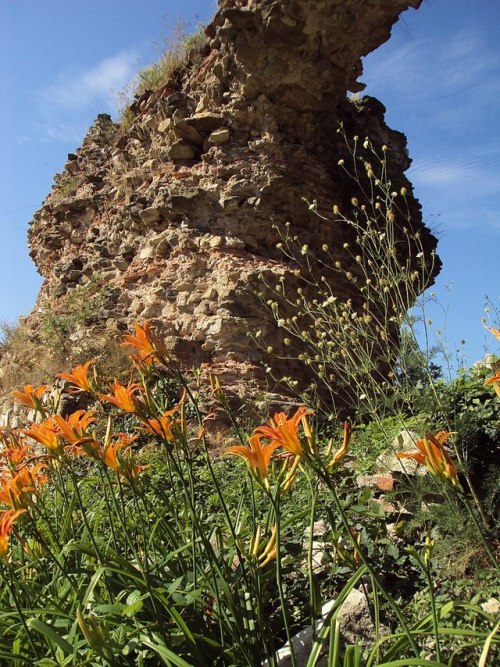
[{"left": 2, "top": 0, "right": 438, "bottom": 408}]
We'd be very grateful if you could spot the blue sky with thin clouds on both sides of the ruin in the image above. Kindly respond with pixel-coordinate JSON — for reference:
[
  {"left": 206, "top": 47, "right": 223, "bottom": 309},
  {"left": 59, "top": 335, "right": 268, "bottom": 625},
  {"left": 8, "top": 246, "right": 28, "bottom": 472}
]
[{"left": 0, "top": 0, "right": 500, "bottom": 370}]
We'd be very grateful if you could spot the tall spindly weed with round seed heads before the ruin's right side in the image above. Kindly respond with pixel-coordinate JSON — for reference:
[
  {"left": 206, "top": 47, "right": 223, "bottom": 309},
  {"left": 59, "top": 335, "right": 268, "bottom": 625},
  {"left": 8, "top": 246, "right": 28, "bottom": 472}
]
[{"left": 258, "top": 128, "right": 437, "bottom": 420}]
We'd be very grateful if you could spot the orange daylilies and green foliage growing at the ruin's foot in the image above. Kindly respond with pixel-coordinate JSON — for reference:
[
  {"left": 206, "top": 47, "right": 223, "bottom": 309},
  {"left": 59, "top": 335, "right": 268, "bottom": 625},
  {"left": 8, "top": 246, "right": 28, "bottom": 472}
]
[{"left": 0, "top": 316, "right": 498, "bottom": 666}]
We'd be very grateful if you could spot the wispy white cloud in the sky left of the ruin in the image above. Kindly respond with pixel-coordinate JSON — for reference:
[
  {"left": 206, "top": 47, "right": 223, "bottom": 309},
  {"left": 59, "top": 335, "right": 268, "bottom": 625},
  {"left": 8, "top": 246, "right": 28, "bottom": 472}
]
[{"left": 42, "top": 51, "right": 138, "bottom": 112}]
